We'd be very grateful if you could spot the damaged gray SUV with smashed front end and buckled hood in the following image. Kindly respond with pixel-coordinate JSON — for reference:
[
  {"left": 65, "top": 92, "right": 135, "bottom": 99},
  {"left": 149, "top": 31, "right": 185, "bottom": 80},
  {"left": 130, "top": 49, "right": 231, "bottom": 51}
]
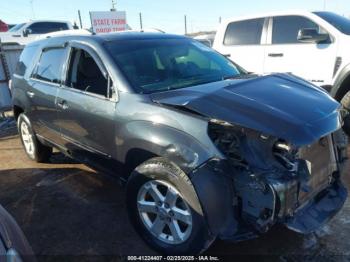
[{"left": 12, "top": 33, "right": 347, "bottom": 254}]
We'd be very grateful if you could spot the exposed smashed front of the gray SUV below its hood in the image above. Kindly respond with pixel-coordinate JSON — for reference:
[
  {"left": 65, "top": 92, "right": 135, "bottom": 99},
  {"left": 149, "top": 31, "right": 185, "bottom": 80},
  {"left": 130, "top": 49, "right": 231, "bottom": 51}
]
[{"left": 193, "top": 120, "right": 347, "bottom": 241}]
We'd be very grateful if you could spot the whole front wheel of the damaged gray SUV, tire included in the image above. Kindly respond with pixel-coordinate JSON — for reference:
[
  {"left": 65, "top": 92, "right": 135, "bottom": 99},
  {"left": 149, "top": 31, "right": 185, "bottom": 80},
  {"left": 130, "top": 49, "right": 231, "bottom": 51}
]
[{"left": 127, "top": 158, "right": 215, "bottom": 255}]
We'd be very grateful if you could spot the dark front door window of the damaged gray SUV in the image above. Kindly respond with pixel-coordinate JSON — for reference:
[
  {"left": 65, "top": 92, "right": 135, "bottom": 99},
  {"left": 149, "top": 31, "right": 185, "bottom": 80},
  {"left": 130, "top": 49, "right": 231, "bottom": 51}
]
[{"left": 66, "top": 48, "right": 108, "bottom": 97}]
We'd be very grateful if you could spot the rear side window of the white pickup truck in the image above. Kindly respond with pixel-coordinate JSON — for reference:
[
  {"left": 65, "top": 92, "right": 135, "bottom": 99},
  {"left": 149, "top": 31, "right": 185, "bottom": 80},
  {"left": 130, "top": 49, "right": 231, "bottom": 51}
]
[{"left": 224, "top": 18, "right": 265, "bottom": 45}]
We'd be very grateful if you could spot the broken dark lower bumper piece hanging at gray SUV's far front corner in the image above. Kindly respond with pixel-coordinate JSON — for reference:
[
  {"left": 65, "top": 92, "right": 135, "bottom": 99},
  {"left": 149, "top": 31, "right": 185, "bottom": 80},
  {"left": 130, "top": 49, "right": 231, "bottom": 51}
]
[{"left": 284, "top": 181, "right": 347, "bottom": 234}]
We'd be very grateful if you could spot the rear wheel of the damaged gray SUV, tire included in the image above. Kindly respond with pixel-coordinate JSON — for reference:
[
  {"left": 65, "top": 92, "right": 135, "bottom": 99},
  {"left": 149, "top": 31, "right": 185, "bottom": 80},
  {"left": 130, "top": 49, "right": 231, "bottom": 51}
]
[{"left": 17, "top": 113, "right": 52, "bottom": 163}]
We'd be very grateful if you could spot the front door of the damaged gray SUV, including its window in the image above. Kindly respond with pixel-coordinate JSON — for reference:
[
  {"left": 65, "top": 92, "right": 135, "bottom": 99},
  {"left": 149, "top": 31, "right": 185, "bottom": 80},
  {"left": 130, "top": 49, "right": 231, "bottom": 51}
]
[{"left": 56, "top": 44, "right": 116, "bottom": 163}]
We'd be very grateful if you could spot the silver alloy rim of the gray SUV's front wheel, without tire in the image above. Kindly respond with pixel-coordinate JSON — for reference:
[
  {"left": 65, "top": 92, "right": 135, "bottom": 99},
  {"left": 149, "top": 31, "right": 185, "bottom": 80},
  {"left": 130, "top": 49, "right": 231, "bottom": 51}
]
[{"left": 137, "top": 180, "right": 192, "bottom": 244}]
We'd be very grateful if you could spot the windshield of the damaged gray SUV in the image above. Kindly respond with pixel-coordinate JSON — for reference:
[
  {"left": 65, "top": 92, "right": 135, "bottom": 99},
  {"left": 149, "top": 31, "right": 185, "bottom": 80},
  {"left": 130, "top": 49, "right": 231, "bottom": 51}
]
[{"left": 106, "top": 39, "right": 244, "bottom": 93}]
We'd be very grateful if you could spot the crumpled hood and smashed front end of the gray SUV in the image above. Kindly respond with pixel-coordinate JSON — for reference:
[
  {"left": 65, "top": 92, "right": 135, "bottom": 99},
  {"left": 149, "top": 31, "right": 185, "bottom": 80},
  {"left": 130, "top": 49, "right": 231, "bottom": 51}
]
[{"left": 152, "top": 74, "right": 347, "bottom": 240}]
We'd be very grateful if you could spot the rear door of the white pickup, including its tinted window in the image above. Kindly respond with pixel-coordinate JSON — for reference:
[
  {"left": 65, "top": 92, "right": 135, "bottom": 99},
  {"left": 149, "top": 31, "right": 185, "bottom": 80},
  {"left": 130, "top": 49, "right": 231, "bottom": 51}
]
[{"left": 216, "top": 18, "right": 267, "bottom": 73}]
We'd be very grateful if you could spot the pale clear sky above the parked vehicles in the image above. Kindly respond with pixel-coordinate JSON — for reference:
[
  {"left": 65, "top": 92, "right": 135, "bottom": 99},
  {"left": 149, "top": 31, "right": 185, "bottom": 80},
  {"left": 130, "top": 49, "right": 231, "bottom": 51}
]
[{"left": 0, "top": 0, "right": 350, "bottom": 34}]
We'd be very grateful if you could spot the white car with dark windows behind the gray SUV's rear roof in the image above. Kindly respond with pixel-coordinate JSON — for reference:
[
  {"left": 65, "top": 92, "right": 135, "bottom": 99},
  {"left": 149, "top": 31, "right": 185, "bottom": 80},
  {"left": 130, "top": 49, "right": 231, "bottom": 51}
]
[{"left": 0, "top": 20, "right": 73, "bottom": 45}]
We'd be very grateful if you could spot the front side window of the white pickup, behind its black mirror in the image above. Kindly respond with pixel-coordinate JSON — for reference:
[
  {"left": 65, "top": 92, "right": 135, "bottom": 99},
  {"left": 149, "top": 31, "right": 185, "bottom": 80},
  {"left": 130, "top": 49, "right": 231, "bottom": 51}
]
[{"left": 272, "top": 16, "right": 320, "bottom": 44}]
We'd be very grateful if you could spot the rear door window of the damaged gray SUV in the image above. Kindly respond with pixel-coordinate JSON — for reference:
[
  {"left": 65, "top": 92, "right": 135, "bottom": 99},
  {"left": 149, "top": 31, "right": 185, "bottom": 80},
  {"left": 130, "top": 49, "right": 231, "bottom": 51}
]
[{"left": 32, "top": 48, "right": 66, "bottom": 84}]
